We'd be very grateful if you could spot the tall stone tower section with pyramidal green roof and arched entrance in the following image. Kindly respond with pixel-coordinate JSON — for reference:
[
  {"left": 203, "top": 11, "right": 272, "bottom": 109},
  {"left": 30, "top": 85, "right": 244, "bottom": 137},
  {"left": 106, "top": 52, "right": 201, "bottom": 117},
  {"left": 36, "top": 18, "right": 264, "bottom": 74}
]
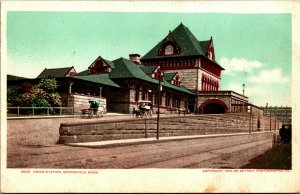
[{"left": 140, "top": 23, "right": 248, "bottom": 113}]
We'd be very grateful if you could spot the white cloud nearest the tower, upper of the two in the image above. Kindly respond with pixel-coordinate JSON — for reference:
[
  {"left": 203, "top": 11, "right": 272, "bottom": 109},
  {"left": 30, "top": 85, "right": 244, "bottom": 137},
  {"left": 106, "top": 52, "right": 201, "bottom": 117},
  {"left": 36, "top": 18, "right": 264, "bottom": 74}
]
[{"left": 219, "top": 57, "right": 263, "bottom": 73}]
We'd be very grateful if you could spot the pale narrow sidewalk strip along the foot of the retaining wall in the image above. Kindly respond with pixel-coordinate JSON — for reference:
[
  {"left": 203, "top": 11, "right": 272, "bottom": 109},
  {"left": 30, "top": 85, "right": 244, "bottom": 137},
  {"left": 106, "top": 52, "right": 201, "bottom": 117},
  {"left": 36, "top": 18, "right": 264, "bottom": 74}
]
[{"left": 65, "top": 131, "right": 270, "bottom": 148}]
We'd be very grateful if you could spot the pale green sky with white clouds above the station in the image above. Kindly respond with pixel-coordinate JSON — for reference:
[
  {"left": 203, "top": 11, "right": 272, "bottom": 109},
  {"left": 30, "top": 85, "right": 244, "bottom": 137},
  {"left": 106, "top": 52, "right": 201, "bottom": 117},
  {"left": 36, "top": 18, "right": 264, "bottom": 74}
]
[{"left": 7, "top": 11, "right": 292, "bottom": 106}]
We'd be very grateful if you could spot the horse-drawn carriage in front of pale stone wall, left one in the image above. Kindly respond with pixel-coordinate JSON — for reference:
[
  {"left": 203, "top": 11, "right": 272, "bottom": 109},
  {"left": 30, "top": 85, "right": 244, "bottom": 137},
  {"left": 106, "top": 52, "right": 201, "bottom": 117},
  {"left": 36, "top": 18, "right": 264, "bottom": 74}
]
[{"left": 81, "top": 99, "right": 106, "bottom": 119}]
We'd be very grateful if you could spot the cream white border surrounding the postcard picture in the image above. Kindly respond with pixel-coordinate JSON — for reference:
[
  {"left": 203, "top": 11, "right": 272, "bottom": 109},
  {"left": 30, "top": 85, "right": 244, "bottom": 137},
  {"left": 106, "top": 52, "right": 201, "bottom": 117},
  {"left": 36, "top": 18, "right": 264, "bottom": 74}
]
[{"left": 1, "top": 1, "right": 300, "bottom": 192}]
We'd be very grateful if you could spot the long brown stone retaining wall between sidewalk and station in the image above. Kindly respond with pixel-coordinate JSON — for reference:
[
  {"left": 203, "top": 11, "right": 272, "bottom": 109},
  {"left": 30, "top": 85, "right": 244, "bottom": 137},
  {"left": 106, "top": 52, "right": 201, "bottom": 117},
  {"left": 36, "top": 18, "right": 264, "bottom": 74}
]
[{"left": 59, "top": 114, "right": 278, "bottom": 143}]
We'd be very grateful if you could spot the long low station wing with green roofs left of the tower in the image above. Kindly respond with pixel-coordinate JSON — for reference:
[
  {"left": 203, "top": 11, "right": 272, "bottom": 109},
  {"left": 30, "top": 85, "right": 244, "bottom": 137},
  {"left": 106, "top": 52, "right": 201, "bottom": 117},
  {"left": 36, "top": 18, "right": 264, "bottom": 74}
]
[{"left": 8, "top": 56, "right": 194, "bottom": 114}]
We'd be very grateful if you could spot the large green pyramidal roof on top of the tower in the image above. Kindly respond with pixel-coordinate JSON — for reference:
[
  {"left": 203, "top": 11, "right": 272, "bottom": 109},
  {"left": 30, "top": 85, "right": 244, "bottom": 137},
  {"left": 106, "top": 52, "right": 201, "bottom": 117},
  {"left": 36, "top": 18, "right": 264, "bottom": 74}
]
[{"left": 141, "top": 23, "right": 205, "bottom": 60}]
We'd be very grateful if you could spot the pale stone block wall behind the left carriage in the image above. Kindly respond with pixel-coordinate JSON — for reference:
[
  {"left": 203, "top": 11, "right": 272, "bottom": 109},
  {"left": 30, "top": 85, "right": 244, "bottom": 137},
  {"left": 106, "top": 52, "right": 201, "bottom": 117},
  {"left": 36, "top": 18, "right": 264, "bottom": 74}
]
[{"left": 68, "top": 94, "right": 106, "bottom": 114}]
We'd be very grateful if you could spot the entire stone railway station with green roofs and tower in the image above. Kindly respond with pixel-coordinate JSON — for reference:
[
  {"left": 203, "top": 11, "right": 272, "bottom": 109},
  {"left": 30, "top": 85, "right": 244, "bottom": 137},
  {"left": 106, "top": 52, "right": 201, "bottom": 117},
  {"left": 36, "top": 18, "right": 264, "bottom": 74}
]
[{"left": 7, "top": 23, "right": 260, "bottom": 114}]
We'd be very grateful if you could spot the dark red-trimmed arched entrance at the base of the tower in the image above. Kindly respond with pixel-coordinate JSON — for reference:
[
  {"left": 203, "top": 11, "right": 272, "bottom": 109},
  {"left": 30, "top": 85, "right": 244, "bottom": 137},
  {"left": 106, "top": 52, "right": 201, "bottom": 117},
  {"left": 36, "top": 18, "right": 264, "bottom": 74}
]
[{"left": 199, "top": 99, "right": 228, "bottom": 114}]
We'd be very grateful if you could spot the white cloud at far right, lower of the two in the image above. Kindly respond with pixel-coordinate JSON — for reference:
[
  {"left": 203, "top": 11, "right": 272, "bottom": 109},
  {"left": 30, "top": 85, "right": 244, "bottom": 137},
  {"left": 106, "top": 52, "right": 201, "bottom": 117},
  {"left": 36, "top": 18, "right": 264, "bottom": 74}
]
[{"left": 248, "top": 68, "right": 290, "bottom": 84}]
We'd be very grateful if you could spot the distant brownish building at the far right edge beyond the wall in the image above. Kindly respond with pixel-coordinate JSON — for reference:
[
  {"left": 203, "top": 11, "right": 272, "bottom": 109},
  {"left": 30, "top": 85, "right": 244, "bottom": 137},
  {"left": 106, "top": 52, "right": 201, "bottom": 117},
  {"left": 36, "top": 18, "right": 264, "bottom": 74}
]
[{"left": 261, "top": 106, "right": 292, "bottom": 124}]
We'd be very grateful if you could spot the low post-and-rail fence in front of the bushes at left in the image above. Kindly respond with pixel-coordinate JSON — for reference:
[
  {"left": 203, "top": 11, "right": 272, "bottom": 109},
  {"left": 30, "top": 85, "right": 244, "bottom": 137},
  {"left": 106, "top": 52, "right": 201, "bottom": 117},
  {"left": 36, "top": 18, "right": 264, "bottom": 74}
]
[{"left": 7, "top": 106, "right": 74, "bottom": 117}]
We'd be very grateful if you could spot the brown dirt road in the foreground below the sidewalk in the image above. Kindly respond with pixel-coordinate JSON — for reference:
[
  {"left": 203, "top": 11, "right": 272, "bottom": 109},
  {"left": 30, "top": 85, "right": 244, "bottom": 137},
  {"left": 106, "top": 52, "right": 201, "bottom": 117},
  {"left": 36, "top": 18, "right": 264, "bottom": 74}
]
[{"left": 7, "top": 115, "right": 272, "bottom": 169}]
